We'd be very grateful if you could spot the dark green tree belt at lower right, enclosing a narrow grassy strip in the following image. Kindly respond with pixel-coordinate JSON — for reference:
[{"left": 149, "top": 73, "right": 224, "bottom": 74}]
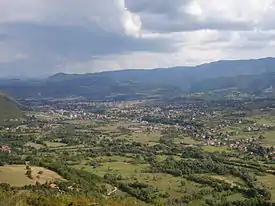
[{"left": 151, "top": 148, "right": 271, "bottom": 203}]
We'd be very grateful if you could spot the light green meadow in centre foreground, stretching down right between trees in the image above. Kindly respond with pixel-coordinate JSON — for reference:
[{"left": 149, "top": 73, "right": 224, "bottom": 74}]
[{"left": 75, "top": 155, "right": 210, "bottom": 201}]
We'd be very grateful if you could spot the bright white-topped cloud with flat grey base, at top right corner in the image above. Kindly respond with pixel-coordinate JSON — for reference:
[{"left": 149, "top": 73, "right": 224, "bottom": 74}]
[{"left": 127, "top": 0, "right": 275, "bottom": 32}]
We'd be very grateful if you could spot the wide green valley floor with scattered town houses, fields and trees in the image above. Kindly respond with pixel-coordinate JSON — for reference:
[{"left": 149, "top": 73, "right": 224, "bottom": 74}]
[{"left": 0, "top": 94, "right": 275, "bottom": 205}]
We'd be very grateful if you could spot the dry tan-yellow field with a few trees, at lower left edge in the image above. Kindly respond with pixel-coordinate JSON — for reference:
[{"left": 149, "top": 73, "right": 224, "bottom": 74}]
[{"left": 0, "top": 165, "right": 63, "bottom": 187}]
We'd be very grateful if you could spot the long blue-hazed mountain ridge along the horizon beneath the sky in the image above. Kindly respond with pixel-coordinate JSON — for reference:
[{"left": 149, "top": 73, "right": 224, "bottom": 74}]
[{"left": 0, "top": 58, "right": 275, "bottom": 100}]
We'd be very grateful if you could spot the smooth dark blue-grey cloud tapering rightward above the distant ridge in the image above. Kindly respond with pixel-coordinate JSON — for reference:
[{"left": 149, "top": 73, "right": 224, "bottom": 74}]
[{"left": 2, "top": 24, "right": 174, "bottom": 59}]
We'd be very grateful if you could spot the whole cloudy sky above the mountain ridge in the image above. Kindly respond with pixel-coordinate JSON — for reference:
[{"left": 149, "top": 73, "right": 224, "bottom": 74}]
[{"left": 0, "top": 0, "right": 275, "bottom": 77}]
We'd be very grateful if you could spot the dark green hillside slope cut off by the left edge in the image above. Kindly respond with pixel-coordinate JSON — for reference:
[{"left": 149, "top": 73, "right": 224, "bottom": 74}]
[{"left": 0, "top": 93, "right": 23, "bottom": 123}]
